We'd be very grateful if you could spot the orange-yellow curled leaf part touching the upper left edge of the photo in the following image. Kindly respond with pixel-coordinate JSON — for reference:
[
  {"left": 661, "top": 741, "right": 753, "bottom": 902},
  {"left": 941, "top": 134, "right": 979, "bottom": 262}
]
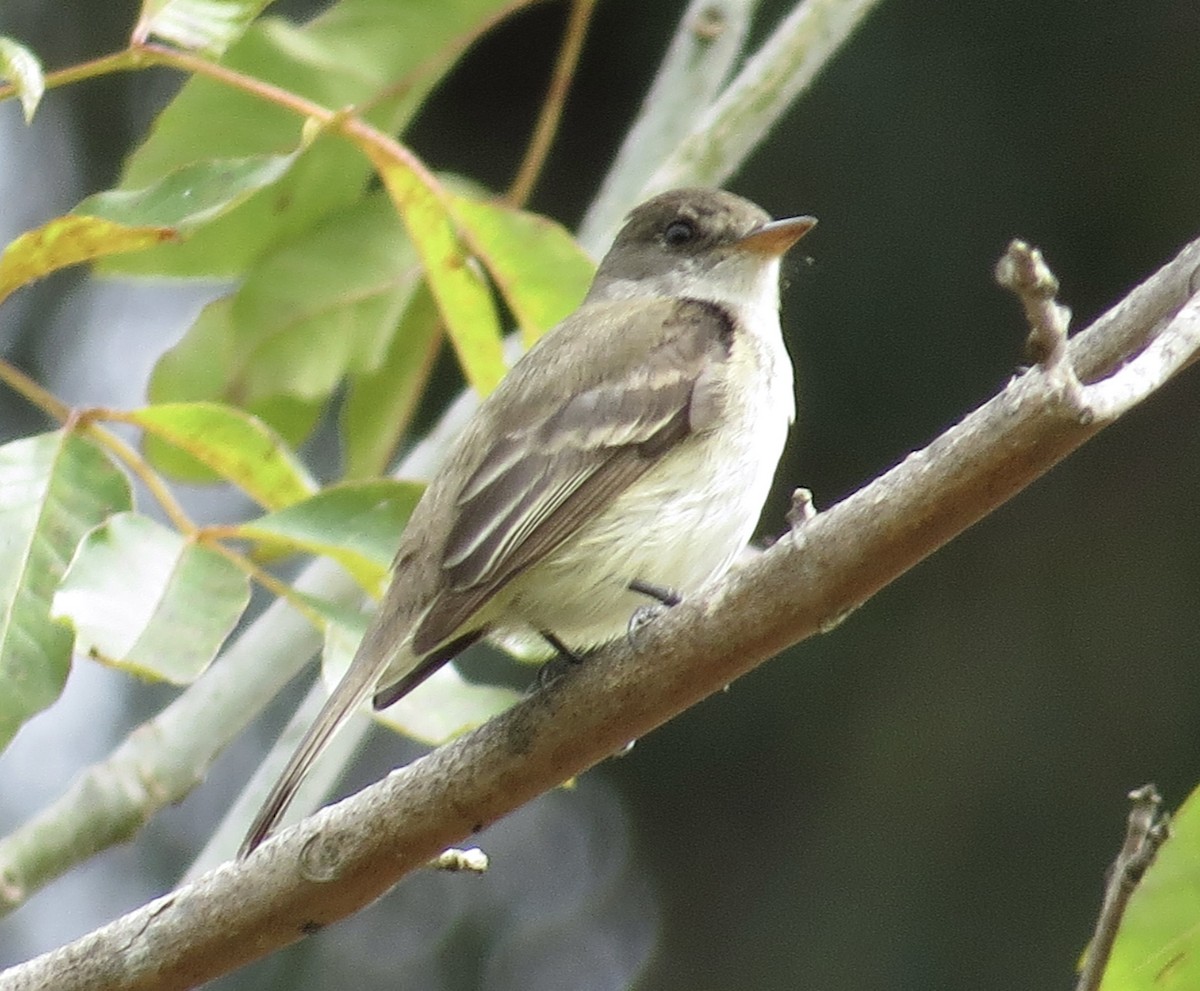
[{"left": 0, "top": 215, "right": 178, "bottom": 302}]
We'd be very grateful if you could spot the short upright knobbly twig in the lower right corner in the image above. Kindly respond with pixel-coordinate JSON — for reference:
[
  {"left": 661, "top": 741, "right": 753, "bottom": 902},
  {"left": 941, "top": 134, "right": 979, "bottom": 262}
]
[{"left": 1075, "top": 785, "right": 1170, "bottom": 991}]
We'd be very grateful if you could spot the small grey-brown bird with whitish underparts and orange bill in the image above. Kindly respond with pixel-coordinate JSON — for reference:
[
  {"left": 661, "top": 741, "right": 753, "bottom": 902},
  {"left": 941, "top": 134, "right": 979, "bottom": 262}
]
[{"left": 239, "top": 188, "right": 816, "bottom": 857}]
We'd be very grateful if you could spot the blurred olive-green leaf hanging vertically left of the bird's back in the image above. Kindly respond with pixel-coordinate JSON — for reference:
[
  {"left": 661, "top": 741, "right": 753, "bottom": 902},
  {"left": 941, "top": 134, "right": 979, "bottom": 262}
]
[{"left": 338, "top": 279, "right": 442, "bottom": 479}]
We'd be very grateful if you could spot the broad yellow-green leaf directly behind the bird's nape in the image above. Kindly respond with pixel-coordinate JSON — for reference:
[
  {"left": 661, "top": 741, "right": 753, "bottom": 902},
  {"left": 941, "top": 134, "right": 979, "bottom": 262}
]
[{"left": 451, "top": 196, "right": 595, "bottom": 346}]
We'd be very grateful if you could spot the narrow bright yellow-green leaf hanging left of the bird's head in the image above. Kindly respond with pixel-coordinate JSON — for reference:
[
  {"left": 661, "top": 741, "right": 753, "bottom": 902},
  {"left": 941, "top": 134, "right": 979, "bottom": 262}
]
[{"left": 368, "top": 154, "right": 505, "bottom": 396}]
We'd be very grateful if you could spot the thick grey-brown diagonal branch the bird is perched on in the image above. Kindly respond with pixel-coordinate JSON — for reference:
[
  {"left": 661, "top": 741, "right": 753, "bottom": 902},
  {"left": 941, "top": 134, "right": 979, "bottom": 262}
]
[{"left": 9, "top": 233, "right": 1200, "bottom": 991}]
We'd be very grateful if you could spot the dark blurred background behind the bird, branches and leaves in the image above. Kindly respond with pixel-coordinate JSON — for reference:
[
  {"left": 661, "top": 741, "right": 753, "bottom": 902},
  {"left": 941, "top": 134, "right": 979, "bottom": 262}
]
[{"left": 0, "top": 0, "right": 1200, "bottom": 991}]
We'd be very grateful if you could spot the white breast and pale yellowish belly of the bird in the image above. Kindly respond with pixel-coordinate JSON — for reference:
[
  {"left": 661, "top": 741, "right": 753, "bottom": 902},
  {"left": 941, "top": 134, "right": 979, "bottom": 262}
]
[{"left": 497, "top": 304, "right": 794, "bottom": 649}]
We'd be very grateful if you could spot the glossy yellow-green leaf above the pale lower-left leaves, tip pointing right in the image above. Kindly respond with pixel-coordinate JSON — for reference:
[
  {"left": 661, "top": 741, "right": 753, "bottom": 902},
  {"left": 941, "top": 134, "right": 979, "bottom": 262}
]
[{"left": 116, "top": 403, "right": 317, "bottom": 509}]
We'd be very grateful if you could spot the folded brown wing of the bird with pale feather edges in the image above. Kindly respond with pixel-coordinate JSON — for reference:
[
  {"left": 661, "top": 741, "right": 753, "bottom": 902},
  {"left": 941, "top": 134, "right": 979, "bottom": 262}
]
[{"left": 413, "top": 300, "right": 733, "bottom": 654}]
